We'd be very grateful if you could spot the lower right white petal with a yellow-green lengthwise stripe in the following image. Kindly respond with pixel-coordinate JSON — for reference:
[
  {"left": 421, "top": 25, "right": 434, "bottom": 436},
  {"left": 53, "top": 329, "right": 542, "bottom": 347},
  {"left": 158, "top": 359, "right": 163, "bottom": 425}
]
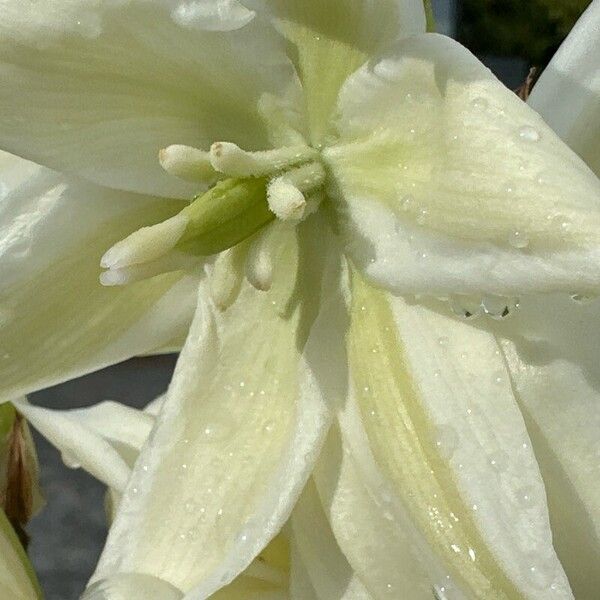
[{"left": 348, "top": 278, "right": 573, "bottom": 599}]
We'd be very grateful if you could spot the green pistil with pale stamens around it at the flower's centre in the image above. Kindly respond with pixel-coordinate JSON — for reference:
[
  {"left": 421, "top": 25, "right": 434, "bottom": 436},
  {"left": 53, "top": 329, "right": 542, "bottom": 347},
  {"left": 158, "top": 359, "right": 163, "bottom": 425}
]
[{"left": 100, "top": 142, "right": 326, "bottom": 300}]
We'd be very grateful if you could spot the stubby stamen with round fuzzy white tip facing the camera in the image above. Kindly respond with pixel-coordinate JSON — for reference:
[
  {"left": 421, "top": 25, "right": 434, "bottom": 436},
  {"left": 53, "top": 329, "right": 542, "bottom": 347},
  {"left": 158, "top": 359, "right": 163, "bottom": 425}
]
[{"left": 267, "top": 162, "right": 325, "bottom": 221}]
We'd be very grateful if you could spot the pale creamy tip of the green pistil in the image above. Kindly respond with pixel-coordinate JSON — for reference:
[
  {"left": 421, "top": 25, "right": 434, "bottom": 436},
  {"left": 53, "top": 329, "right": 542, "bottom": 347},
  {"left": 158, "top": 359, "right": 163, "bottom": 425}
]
[{"left": 100, "top": 213, "right": 189, "bottom": 270}]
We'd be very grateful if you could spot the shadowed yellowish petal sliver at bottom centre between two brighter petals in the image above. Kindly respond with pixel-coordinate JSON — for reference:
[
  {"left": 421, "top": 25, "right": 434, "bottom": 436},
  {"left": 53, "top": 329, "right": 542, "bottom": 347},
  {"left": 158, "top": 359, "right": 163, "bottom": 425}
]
[{"left": 291, "top": 479, "right": 372, "bottom": 600}]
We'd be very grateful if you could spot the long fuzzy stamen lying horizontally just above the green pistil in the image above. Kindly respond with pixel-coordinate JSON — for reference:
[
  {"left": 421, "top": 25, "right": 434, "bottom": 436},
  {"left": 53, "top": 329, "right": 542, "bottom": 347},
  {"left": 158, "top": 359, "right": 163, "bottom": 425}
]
[{"left": 210, "top": 142, "right": 317, "bottom": 177}]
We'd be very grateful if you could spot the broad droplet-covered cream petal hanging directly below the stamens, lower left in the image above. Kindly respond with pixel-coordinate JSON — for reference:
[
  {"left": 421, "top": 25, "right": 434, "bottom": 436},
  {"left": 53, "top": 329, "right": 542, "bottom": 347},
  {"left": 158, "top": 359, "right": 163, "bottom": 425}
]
[{"left": 86, "top": 223, "right": 338, "bottom": 600}]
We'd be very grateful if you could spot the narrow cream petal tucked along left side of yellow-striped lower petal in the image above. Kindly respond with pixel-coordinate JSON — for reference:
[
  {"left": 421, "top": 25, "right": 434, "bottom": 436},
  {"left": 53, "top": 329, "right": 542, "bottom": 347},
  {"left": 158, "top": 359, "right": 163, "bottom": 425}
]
[{"left": 314, "top": 424, "right": 446, "bottom": 600}]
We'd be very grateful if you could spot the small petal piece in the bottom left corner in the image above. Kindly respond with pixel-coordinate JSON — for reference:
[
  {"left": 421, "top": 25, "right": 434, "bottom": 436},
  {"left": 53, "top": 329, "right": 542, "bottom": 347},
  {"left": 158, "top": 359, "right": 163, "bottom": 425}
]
[{"left": 0, "top": 509, "right": 42, "bottom": 600}]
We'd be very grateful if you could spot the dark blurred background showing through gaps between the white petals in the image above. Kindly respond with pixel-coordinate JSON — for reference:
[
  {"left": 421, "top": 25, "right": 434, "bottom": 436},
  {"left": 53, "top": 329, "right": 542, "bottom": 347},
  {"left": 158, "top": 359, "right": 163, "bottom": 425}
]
[{"left": 23, "top": 0, "right": 590, "bottom": 600}]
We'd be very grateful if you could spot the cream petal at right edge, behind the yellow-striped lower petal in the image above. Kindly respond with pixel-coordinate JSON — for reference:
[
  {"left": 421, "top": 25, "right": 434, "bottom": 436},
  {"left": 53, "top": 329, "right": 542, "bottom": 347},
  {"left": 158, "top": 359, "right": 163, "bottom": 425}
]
[{"left": 499, "top": 297, "right": 600, "bottom": 599}]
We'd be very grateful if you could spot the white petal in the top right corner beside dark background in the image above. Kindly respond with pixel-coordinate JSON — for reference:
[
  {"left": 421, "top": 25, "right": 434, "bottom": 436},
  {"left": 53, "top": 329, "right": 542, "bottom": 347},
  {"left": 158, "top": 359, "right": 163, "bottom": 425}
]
[{"left": 528, "top": 0, "right": 600, "bottom": 176}]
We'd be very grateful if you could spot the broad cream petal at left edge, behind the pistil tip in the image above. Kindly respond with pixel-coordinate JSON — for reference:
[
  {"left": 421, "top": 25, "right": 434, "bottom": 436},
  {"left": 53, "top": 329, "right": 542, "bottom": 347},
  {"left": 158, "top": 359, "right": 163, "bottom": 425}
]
[{"left": 0, "top": 170, "right": 198, "bottom": 400}]
